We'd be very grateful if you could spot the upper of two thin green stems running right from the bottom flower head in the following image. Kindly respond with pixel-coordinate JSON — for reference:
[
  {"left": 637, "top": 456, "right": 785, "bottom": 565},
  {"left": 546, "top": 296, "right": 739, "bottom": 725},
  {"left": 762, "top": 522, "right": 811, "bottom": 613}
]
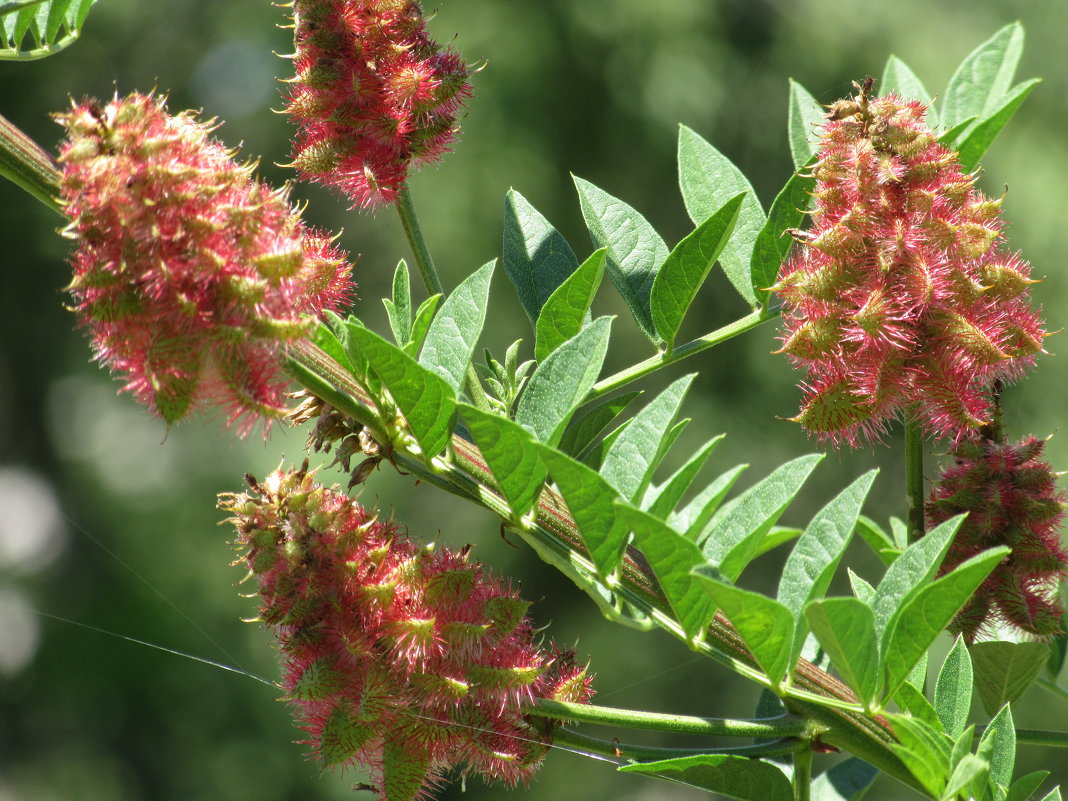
[{"left": 524, "top": 698, "right": 808, "bottom": 738}]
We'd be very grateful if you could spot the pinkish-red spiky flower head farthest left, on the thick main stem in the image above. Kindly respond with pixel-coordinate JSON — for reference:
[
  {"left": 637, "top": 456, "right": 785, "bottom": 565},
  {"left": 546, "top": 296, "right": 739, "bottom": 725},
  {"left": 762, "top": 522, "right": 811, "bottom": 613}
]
[{"left": 57, "top": 94, "right": 351, "bottom": 440}]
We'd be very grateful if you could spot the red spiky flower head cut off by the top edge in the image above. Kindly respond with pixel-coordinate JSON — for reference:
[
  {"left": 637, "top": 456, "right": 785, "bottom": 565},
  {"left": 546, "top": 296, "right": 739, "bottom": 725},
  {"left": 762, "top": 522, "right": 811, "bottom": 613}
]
[{"left": 285, "top": 0, "right": 471, "bottom": 207}]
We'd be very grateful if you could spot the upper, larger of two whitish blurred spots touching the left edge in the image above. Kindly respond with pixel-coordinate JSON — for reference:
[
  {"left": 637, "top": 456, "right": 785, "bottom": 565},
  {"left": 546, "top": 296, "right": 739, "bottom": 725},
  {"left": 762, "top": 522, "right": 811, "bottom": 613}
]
[{"left": 0, "top": 467, "right": 67, "bottom": 572}]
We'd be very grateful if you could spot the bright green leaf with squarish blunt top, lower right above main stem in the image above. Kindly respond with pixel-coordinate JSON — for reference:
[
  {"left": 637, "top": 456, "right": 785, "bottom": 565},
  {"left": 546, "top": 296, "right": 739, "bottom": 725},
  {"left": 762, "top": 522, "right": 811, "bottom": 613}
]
[{"left": 804, "top": 598, "right": 879, "bottom": 705}]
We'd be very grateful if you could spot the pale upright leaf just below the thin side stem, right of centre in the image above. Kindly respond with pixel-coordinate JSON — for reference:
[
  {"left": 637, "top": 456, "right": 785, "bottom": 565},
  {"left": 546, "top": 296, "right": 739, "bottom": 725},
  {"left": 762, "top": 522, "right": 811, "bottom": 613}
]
[{"left": 600, "top": 375, "right": 693, "bottom": 504}]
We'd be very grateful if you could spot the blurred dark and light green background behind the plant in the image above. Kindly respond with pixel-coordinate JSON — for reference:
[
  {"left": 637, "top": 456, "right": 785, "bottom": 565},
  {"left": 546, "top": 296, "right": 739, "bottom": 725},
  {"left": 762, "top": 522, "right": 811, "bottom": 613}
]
[{"left": 0, "top": 0, "right": 1068, "bottom": 801}]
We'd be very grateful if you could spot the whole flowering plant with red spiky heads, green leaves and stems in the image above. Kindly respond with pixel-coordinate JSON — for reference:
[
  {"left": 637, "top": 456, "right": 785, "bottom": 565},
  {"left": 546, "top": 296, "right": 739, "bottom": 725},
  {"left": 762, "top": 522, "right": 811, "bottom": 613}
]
[{"left": 6, "top": 0, "right": 1068, "bottom": 801}]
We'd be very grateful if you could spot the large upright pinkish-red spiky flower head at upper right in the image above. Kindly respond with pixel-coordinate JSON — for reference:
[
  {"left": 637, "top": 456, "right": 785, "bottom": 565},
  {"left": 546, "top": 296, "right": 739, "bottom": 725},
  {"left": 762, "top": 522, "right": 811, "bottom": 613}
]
[{"left": 772, "top": 82, "right": 1046, "bottom": 445}]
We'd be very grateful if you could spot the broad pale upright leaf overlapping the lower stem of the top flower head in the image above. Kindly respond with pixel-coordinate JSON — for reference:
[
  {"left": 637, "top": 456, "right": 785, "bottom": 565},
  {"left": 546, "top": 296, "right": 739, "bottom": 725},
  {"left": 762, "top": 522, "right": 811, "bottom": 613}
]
[{"left": 419, "top": 262, "right": 496, "bottom": 397}]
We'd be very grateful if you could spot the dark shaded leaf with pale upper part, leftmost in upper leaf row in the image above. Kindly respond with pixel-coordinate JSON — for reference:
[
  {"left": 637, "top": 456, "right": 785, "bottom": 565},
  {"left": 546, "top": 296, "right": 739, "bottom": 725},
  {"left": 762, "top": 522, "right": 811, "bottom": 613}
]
[{"left": 503, "top": 189, "right": 579, "bottom": 326}]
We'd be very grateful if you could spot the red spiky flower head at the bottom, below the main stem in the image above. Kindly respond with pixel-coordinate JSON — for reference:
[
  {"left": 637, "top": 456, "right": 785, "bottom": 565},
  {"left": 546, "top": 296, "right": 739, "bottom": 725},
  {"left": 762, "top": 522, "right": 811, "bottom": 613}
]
[{"left": 220, "top": 462, "right": 592, "bottom": 801}]
